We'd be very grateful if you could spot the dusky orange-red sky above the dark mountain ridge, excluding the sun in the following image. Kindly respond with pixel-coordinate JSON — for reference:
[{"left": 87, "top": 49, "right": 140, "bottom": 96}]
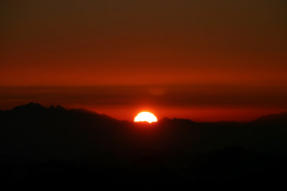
[{"left": 0, "top": 0, "right": 287, "bottom": 121}]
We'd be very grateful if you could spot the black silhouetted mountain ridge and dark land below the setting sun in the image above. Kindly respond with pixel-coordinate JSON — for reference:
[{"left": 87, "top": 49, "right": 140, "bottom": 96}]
[{"left": 0, "top": 104, "right": 287, "bottom": 190}]
